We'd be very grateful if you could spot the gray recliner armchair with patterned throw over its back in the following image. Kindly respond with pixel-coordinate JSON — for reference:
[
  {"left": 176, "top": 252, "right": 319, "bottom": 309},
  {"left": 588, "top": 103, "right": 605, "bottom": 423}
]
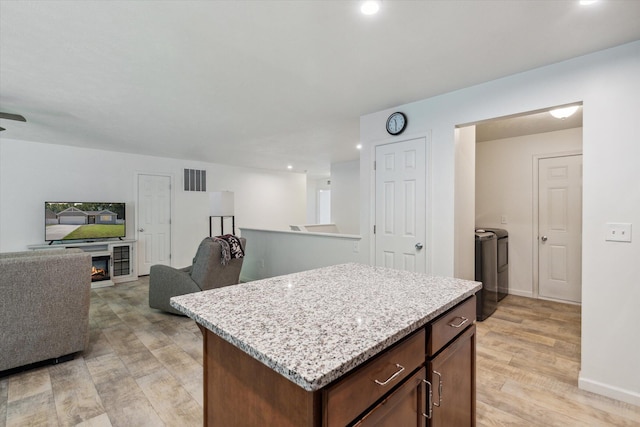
[{"left": 149, "top": 237, "right": 247, "bottom": 315}]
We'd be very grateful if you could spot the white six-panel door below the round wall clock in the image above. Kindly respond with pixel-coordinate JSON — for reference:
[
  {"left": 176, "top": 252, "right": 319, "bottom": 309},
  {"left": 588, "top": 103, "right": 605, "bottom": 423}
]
[{"left": 375, "top": 138, "right": 427, "bottom": 273}]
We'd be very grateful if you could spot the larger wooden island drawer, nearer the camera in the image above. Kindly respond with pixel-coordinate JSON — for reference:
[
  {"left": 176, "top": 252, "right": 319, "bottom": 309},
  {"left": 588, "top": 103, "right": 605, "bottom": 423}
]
[{"left": 323, "top": 329, "right": 426, "bottom": 426}]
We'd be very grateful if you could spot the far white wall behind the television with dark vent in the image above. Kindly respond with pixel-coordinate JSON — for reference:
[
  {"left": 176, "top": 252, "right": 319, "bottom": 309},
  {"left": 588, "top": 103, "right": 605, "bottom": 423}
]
[{"left": 0, "top": 138, "right": 306, "bottom": 267}]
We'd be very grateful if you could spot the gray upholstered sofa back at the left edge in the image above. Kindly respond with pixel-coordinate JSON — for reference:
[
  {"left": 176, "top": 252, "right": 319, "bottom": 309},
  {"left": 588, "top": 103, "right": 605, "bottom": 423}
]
[{"left": 0, "top": 249, "right": 91, "bottom": 371}]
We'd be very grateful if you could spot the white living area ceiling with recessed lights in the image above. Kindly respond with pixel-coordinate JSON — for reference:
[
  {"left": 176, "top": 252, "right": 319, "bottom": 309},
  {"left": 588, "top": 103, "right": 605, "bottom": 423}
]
[{"left": 0, "top": 0, "right": 640, "bottom": 176}]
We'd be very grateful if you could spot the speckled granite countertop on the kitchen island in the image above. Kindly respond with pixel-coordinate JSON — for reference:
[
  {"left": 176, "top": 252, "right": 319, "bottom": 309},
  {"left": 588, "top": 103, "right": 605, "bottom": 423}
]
[{"left": 171, "top": 263, "right": 481, "bottom": 391}]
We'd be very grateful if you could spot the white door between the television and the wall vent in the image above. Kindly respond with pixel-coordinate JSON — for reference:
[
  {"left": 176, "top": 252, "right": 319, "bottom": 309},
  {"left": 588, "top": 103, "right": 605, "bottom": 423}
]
[{"left": 137, "top": 174, "right": 171, "bottom": 275}]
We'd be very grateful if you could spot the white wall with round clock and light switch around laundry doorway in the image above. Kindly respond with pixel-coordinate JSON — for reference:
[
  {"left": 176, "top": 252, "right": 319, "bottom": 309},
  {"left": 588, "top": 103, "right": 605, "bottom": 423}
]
[{"left": 360, "top": 41, "right": 640, "bottom": 404}]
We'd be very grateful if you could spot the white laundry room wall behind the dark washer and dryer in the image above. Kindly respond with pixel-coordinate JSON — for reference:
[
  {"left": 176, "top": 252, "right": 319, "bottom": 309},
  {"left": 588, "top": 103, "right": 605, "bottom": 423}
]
[{"left": 475, "top": 128, "right": 582, "bottom": 297}]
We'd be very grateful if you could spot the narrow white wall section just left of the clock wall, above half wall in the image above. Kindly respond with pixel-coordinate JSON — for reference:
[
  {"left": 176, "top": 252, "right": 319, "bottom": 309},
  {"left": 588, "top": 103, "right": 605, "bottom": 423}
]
[{"left": 331, "top": 160, "right": 360, "bottom": 234}]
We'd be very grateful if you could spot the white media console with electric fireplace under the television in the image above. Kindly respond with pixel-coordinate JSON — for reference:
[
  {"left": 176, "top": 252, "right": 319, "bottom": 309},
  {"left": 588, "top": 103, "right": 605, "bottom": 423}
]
[{"left": 28, "top": 239, "right": 138, "bottom": 289}]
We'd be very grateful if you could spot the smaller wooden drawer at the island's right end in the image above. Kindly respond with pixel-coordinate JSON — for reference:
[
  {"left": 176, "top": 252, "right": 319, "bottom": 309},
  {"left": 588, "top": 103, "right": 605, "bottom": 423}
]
[{"left": 427, "top": 295, "right": 476, "bottom": 356}]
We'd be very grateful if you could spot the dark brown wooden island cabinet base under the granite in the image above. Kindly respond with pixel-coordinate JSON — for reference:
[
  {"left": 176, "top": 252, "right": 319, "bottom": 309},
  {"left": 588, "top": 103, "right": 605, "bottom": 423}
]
[{"left": 201, "top": 296, "right": 476, "bottom": 427}]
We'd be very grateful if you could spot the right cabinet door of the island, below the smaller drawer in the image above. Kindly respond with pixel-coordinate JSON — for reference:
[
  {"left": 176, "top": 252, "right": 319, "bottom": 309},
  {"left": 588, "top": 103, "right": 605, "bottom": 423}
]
[{"left": 427, "top": 325, "right": 476, "bottom": 427}]
